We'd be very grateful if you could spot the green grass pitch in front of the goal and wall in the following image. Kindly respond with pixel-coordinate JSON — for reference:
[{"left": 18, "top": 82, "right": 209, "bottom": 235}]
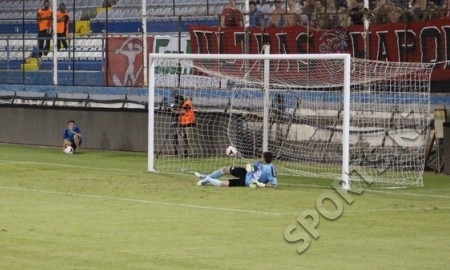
[{"left": 0, "top": 144, "right": 450, "bottom": 270}]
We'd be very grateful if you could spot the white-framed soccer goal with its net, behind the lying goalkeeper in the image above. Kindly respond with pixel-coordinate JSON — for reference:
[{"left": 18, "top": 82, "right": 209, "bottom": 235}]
[{"left": 148, "top": 51, "right": 432, "bottom": 188}]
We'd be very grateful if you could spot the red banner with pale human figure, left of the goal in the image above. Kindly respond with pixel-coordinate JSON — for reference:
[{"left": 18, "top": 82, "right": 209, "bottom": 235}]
[{"left": 106, "top": 36, "right": 154, "bottom": 87}]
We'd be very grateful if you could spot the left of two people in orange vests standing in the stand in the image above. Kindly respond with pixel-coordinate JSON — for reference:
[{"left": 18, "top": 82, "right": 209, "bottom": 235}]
[{"left": 36, "top": 0, "right": 53, "bottom": 57}]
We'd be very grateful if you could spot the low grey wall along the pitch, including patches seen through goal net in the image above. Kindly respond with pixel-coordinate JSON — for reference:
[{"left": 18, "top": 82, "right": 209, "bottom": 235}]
[{"left": 0, "top": 104, "right": 235, "bottom": 155}]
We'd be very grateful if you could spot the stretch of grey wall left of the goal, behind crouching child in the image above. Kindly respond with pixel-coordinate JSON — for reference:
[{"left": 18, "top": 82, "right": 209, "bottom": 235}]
[{"left": 0, "top": 105, "right": 148, "bottom": 151}]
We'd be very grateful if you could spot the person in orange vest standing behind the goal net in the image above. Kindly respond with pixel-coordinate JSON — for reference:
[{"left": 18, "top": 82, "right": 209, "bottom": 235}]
[{"left": 171, "top": 97, "right": 197, "bottom": 157}]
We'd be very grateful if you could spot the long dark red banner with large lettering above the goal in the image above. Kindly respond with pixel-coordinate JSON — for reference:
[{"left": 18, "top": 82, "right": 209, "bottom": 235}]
[{"left": 189, "top": 17, "right": 450, "bottom": 81}]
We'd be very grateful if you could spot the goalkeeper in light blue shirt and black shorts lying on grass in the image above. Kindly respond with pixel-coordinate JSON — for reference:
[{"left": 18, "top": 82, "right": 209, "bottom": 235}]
[{"left": 195, "top": 152, "right": 277, "bottom": 188}]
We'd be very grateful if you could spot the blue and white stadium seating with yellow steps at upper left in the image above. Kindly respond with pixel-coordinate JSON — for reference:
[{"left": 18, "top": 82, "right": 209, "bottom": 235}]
[{"left": 0, "top": 0, "right": 239, "bottom": 82}]
